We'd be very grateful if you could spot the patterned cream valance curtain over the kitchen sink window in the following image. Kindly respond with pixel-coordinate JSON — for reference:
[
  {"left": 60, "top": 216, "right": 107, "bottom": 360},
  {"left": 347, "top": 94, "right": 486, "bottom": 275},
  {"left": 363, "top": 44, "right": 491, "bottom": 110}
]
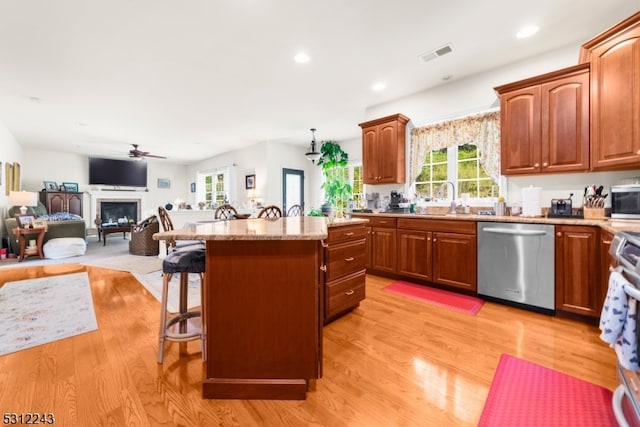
[{"left": 409, "top": 111, "right": 500, "bottom": 183}]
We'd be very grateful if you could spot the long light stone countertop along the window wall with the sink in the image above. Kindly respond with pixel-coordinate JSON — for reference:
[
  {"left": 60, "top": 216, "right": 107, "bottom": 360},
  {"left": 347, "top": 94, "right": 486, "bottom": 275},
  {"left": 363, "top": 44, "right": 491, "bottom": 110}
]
[{"left": 354, "top": 212, "right": 640, "bottom": 234}]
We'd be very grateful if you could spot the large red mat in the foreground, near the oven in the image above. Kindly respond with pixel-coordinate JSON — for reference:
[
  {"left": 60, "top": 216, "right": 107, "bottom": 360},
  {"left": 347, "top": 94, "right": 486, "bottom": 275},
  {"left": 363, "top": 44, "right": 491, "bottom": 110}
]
[{"left": 478, "top": 354, "right": 618, "bottom": 427}]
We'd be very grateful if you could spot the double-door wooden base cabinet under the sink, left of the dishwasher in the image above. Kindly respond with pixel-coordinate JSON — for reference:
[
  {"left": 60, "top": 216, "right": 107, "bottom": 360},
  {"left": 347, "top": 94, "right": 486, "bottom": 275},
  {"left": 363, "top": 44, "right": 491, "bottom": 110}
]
[{"left": 398, "top": 218, "right": 477, "bottom": 292}]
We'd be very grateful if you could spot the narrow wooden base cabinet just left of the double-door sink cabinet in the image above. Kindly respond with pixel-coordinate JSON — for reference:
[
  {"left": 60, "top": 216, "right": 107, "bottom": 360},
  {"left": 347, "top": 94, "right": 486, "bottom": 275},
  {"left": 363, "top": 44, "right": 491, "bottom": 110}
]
[{"left": 368, "top": 217, "right": 397, "bottom": 273}]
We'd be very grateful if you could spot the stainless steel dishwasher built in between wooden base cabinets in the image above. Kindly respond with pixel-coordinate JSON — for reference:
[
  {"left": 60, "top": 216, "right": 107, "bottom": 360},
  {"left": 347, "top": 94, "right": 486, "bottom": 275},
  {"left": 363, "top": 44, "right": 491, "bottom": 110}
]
[{"left": 478, "top": 222, "right": 555, "bottom": 312}]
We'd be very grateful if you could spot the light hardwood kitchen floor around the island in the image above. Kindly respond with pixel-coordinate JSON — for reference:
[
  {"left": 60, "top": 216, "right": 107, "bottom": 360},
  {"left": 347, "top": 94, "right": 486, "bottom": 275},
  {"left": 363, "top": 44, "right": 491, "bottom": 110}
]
[{"left": 0, "top": 265, "right": 616, "bottom": 426}]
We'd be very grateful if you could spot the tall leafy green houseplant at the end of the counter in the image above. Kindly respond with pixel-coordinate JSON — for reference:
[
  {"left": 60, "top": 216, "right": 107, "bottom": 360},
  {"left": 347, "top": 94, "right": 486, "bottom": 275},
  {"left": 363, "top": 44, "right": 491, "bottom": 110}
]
[{"left": 318, "top": 141, "right": 353, "bottom": 217}]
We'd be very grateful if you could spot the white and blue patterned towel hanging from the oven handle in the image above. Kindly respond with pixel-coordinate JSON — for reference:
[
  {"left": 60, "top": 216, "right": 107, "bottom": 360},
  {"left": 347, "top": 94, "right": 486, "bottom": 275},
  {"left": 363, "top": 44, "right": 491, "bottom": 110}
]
[{"left": 600, "top": 271, "right": 629, "bottom": 346}]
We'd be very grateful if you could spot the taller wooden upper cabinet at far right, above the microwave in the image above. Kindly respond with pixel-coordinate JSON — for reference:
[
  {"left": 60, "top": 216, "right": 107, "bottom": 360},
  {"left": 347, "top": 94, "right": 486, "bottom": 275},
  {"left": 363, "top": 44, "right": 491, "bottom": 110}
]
[{"left": 580, "top": 13, "right": 640, "bottom": 170}]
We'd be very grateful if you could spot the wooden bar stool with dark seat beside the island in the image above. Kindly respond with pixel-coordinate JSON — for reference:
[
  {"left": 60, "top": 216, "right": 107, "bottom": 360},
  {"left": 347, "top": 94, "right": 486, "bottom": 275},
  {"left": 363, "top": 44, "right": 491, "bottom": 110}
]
[{"left": 158, "top": 245, "right": 207, "bottom": 363}]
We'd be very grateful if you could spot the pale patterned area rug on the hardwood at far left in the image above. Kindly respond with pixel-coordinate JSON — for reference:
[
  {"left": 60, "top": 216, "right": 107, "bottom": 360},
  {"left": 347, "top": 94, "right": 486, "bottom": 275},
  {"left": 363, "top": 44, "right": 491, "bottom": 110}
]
[{"left": 0, "top": 272, "right": 98, "bottom": 355}]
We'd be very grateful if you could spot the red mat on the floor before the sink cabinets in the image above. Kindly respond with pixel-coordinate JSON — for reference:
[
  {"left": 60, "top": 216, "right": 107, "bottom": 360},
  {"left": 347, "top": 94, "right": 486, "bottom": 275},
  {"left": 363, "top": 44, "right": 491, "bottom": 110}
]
[{"left": 382, "top": 281, "right": 484, "bottom": 316}]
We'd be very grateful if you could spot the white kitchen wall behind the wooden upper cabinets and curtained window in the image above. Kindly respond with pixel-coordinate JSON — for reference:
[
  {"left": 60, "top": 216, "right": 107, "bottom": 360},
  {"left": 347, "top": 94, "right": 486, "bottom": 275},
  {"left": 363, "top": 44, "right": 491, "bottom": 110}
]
[{"left": 365, "top": 44, "right": 640, "bottom": 207}]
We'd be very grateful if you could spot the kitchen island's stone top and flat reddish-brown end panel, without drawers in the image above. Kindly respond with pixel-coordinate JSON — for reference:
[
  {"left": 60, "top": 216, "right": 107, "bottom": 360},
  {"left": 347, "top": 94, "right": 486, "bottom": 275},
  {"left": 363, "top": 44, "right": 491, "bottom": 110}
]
[{"left": 154, "top": 217, "right": 366, "bottom": 399}]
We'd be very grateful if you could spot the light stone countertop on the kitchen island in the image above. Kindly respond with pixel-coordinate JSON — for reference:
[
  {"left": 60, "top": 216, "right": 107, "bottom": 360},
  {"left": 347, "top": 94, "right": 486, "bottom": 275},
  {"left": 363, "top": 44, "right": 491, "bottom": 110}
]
[{"left": 153, "top": 216, "right": 368, "bottom": 240}]
